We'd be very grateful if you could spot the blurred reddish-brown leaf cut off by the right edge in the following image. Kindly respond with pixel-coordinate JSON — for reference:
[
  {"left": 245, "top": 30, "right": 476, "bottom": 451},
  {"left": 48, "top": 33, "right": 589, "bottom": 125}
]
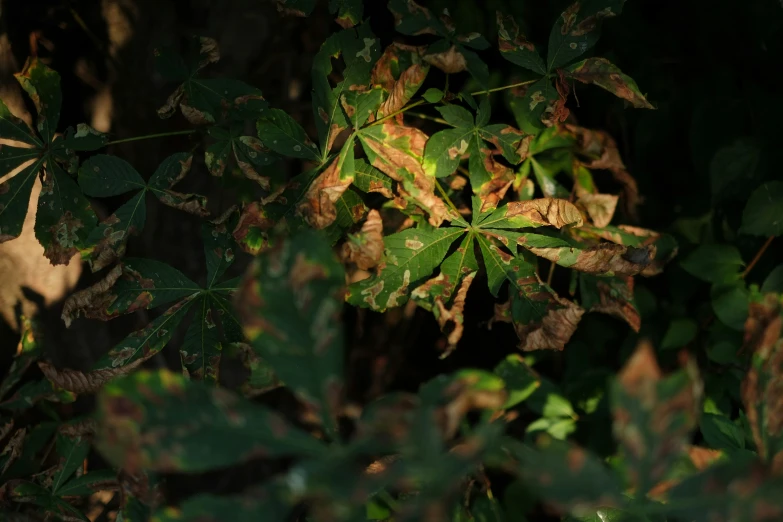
[{"left": 741, "top": 294, "right": 783, "bottom": 474}]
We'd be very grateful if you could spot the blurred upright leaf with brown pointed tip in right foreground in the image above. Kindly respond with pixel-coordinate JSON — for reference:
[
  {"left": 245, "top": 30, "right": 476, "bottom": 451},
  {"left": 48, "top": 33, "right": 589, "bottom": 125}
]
[{"left": 611, "top": 342, "right": 701, "bottom": 494}]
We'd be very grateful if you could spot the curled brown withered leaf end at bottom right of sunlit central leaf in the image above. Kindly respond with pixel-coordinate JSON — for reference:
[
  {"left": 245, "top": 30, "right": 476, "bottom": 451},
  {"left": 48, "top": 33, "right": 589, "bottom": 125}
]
[{"left": 514, "top": 299, "right": 585, "bottom": 352}]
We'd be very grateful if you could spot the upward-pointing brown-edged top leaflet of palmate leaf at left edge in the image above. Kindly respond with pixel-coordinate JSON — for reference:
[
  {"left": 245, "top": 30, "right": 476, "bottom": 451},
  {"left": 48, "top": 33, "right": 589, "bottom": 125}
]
[{"left": 14, "top": 58, "right": 62, "bottom": 143}]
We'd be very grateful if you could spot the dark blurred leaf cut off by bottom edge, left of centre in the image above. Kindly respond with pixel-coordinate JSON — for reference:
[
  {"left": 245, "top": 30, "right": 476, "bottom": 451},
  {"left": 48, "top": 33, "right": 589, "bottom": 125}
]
[{"left": 154, "top": 490, "right": 291, "bottom": 522}]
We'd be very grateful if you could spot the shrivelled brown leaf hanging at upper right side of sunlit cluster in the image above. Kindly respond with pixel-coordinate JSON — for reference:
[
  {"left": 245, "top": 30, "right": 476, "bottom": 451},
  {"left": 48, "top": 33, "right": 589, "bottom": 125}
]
[{"left": 565, "top": 124, "right": 640, "bottom": 220}]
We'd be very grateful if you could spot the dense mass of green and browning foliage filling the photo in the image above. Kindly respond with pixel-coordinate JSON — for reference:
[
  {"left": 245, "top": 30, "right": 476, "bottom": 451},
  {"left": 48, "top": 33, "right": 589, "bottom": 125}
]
[{"left": 0, "top": 0, "right": 783, "bottom": 522}]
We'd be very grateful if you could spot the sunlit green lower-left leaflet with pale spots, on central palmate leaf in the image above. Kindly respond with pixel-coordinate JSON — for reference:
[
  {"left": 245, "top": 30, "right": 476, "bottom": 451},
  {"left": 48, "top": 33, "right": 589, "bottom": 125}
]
[{"left": 346, "top": 227, "right": 465, "bottom": 312}]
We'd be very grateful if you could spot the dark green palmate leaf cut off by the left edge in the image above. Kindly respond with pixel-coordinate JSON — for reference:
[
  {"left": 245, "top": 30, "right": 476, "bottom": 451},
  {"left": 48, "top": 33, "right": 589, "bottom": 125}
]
[{"left": 0, "top": 58, "right": 106, "bottom": 256}]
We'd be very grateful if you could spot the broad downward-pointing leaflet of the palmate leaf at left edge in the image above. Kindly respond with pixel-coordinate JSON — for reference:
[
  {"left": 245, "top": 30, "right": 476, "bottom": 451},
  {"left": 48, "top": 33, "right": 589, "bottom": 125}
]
[{"left": 35, "top": 157, "right": 97, "bottom": 265}]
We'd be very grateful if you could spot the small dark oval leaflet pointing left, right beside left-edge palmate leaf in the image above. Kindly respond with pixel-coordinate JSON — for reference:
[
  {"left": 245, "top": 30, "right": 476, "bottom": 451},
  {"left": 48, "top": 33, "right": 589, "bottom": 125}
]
[{"left": 79, "top": 154, "right": 147, "bottom": 198}]
